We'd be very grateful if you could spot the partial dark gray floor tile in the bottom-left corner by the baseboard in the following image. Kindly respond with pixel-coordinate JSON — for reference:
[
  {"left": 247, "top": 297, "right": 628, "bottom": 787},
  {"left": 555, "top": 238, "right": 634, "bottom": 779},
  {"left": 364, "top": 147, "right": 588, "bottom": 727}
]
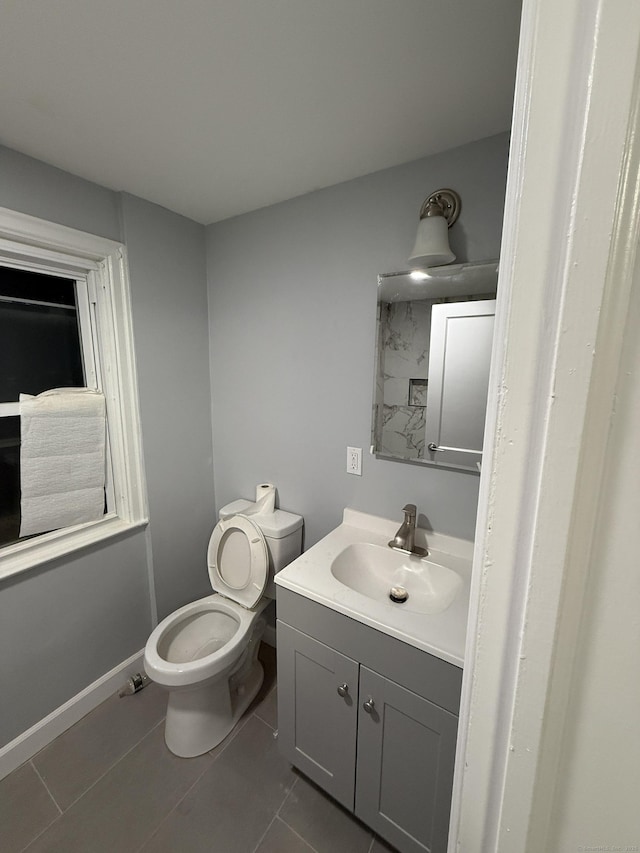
[{"left": 0, "top": 764, "right": 60, "bottom": 853}]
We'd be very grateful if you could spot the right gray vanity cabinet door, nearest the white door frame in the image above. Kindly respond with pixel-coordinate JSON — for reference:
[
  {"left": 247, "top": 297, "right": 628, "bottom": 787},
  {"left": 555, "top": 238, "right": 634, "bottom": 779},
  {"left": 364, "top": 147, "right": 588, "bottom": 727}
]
[{"left": 355, "top": 666, "right": 458, "bottom": 853}]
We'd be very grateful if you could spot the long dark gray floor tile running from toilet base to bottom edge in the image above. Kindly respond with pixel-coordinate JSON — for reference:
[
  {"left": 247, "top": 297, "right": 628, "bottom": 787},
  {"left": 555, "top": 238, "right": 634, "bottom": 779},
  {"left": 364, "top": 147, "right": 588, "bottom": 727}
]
[{"left": 29, "top": 720, "right": 213, "bottom": 853}]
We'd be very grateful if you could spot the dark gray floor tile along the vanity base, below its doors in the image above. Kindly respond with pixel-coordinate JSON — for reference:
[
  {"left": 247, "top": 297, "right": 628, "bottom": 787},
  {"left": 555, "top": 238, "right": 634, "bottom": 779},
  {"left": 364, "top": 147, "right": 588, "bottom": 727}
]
[{"left": 279, "top": 774, "right": 372, "bottom": 853}]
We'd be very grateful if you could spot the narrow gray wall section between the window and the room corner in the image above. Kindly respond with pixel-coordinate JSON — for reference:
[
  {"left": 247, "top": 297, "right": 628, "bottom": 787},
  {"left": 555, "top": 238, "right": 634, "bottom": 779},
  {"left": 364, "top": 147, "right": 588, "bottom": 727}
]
[{"left": 122, "top": 195, "right": 215, "bottom": 619}]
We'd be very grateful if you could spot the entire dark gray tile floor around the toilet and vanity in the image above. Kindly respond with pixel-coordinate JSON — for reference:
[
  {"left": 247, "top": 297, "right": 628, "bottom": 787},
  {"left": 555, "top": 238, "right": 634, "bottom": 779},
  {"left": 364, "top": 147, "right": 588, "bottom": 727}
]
[{"left": 0, "top": 645, "right": 392, "bottom": 853}]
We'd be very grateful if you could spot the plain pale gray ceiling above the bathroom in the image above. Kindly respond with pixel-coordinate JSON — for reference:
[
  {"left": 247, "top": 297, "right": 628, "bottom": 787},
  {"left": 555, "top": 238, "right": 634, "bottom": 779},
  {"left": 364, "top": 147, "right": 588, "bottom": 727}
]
[{"left": 0, "top": 0, "right": 520, "bottom": 223}]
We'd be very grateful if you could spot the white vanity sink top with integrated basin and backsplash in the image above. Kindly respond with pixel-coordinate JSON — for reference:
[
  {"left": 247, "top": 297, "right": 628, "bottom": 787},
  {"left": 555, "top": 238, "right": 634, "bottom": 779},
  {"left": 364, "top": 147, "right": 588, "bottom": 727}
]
[{"left": 275, "top": 509, "right": 473, "bottom": 666}]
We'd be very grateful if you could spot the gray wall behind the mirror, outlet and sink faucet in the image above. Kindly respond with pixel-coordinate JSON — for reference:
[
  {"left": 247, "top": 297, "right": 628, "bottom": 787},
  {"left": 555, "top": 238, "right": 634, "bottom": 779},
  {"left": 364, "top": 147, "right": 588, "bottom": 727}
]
[{"left": 207, "top": 134, "right": 508, "bottom": 547}]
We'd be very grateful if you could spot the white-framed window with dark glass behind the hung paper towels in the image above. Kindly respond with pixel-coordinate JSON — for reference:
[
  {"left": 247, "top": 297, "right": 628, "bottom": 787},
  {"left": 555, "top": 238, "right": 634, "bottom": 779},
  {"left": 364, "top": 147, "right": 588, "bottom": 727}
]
[{"left": 0, "top": 208, "right": 147, "bottom": 577}]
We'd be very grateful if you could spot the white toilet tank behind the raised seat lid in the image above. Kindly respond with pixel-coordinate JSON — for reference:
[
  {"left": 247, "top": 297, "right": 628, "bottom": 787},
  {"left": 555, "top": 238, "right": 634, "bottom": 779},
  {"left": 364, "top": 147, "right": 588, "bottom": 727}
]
[{"left": 219, "top": 500, "right": 303, "bottom": 598}]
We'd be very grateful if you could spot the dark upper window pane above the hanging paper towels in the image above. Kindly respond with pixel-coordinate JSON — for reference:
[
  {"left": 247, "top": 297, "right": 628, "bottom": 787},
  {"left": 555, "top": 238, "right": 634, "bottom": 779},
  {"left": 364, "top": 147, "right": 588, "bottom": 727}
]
[{"left": 0, "top": 267, "right": 85, "bottom": 403}]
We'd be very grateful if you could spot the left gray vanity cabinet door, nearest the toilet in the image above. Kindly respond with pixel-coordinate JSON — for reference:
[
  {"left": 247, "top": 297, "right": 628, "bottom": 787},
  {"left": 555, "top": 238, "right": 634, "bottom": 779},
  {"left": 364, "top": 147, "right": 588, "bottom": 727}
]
[{"left": 277, "top": 621, "right": 358, "bottom": 811}]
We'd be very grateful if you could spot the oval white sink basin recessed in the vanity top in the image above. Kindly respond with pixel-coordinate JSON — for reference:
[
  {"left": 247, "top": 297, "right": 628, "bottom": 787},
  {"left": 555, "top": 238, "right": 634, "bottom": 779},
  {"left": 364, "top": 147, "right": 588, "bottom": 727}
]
[{"left": 331, "top": 542, "right": 463, "bottom": 615}]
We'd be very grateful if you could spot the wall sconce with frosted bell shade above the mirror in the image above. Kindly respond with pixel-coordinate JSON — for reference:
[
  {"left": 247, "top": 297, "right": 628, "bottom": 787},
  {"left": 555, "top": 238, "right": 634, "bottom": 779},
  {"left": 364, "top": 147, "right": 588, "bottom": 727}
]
[{"left": 409, "top": 190, "right": 461, "bottom": 268}]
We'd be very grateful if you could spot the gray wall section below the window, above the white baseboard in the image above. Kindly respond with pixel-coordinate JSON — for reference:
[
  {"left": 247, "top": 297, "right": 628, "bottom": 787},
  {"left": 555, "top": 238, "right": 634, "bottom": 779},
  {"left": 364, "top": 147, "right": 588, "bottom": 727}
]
[{"left": 0, "top": 532, "right": 151, "bottom": 746}]
